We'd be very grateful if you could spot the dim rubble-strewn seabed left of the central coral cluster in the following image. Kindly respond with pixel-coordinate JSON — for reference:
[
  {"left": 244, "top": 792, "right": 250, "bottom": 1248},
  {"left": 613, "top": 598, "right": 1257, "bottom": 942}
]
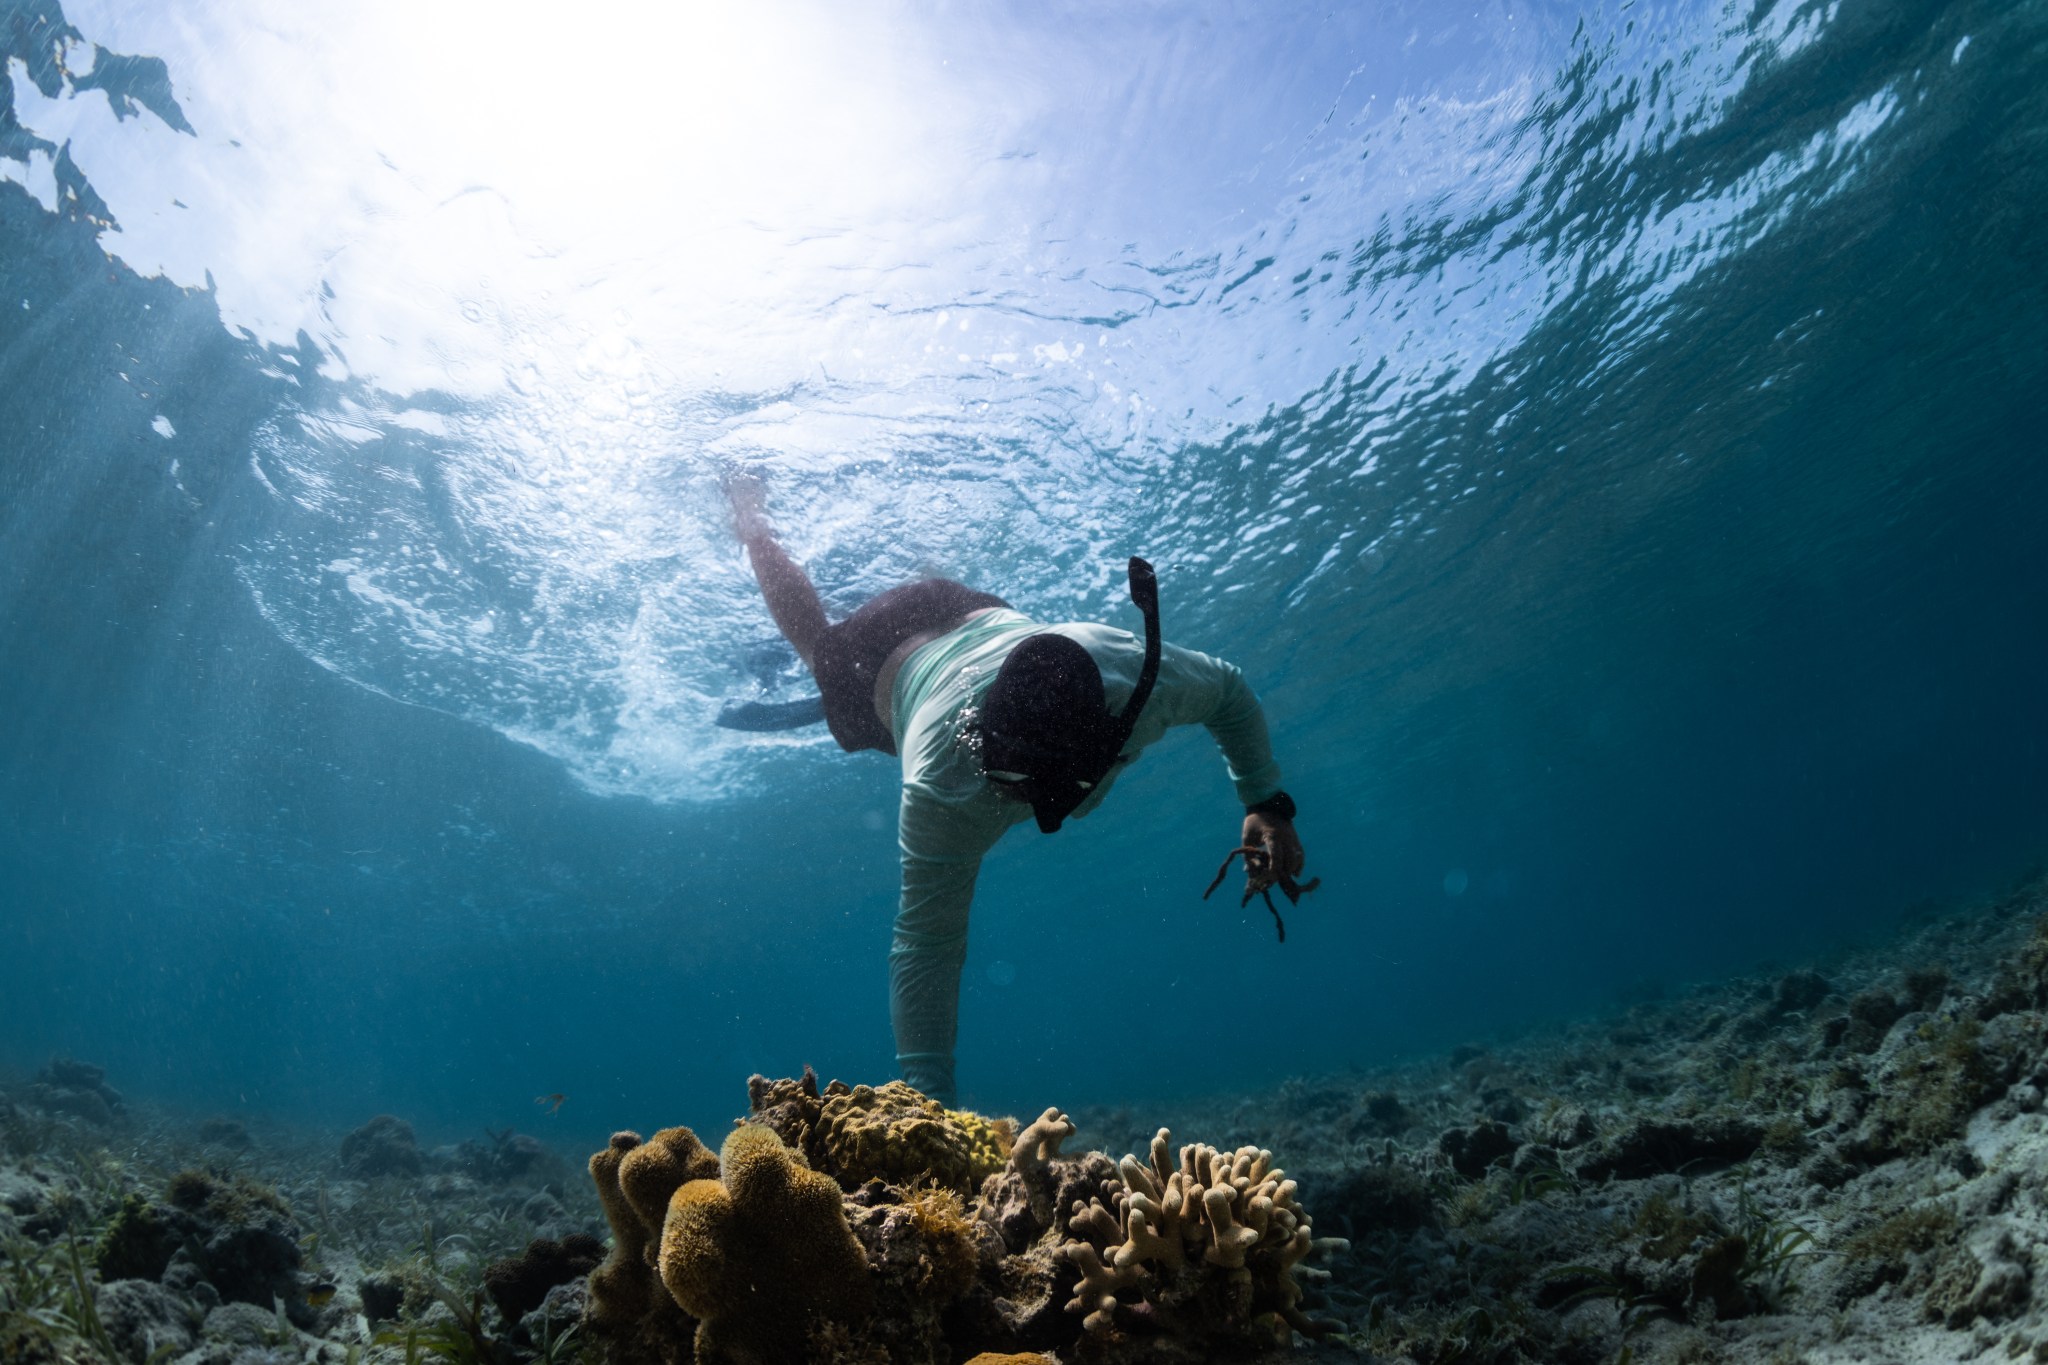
[{"left": 0, "top": 1066, "right": 602, "bottom": 1365}]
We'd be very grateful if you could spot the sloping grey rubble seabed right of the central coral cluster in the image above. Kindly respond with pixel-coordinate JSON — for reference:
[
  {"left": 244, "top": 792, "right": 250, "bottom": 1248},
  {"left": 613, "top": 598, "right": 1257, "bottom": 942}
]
[{"left": 1048, "top": 878, "right": 2048, "bottom": 1365}]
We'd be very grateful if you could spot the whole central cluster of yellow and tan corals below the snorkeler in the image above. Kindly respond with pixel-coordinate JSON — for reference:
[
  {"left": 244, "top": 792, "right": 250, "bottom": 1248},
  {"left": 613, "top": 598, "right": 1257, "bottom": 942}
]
[{"left": 565, "top": 1074, "right": 1337, "bottom": 1365}]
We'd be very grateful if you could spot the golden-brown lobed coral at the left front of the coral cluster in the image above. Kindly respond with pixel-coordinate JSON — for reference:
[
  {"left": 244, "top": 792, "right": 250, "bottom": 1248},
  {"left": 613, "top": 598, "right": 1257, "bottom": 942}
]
[{"left": 659, "top": 1124, "right": 872, "bottom": 1365}]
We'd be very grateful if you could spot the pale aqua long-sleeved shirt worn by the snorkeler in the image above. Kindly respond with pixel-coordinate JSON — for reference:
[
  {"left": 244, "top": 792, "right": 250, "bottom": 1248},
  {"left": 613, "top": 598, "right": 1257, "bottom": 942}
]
[{"left": 889, "top": 610, "right": 1280, "bottom": 1105}]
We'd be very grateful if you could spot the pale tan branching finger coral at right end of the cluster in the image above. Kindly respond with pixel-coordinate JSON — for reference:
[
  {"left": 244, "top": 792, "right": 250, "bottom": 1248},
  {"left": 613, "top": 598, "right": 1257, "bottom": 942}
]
[{"left": 1067, "top": 1128, "right": 1341, "bottom": 1347}]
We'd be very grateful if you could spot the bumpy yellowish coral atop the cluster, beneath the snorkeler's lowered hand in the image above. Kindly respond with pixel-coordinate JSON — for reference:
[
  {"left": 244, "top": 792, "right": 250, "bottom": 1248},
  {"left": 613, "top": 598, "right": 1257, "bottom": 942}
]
[{"left": 817, "top": 1081, "right": 1014, "bottom": 1195}]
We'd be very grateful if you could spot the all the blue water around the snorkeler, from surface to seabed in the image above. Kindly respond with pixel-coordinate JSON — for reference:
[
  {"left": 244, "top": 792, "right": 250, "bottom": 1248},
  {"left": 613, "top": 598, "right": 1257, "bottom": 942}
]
[{"left": 0, "top": 0, "right": 2048, "bottom": 1140}]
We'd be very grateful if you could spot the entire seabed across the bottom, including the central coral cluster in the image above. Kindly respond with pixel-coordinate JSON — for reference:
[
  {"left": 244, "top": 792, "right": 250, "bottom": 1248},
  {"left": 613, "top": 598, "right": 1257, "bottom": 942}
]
[{"left": 0, "top": 878, "right": 2048, "bottom": 1365}]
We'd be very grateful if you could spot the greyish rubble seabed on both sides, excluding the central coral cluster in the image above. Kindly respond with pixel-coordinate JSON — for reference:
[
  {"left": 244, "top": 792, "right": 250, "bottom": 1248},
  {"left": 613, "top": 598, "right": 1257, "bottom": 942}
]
[{"left": 12, "top": 878, "right": 2048, "bottom": 1365}]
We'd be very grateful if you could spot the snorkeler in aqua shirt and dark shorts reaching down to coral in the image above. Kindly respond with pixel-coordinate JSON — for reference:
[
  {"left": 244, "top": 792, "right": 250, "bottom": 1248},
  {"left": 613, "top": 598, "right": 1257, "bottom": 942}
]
[{"left": 721, "top": 475, "right": 1315, "bottom": 1105}]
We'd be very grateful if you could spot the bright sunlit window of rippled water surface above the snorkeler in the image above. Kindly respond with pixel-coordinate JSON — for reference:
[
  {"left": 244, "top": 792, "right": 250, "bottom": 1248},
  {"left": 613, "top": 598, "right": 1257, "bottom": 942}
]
[{"left": 44, "top": 6, "right": 1900, "bottom": 798}]
